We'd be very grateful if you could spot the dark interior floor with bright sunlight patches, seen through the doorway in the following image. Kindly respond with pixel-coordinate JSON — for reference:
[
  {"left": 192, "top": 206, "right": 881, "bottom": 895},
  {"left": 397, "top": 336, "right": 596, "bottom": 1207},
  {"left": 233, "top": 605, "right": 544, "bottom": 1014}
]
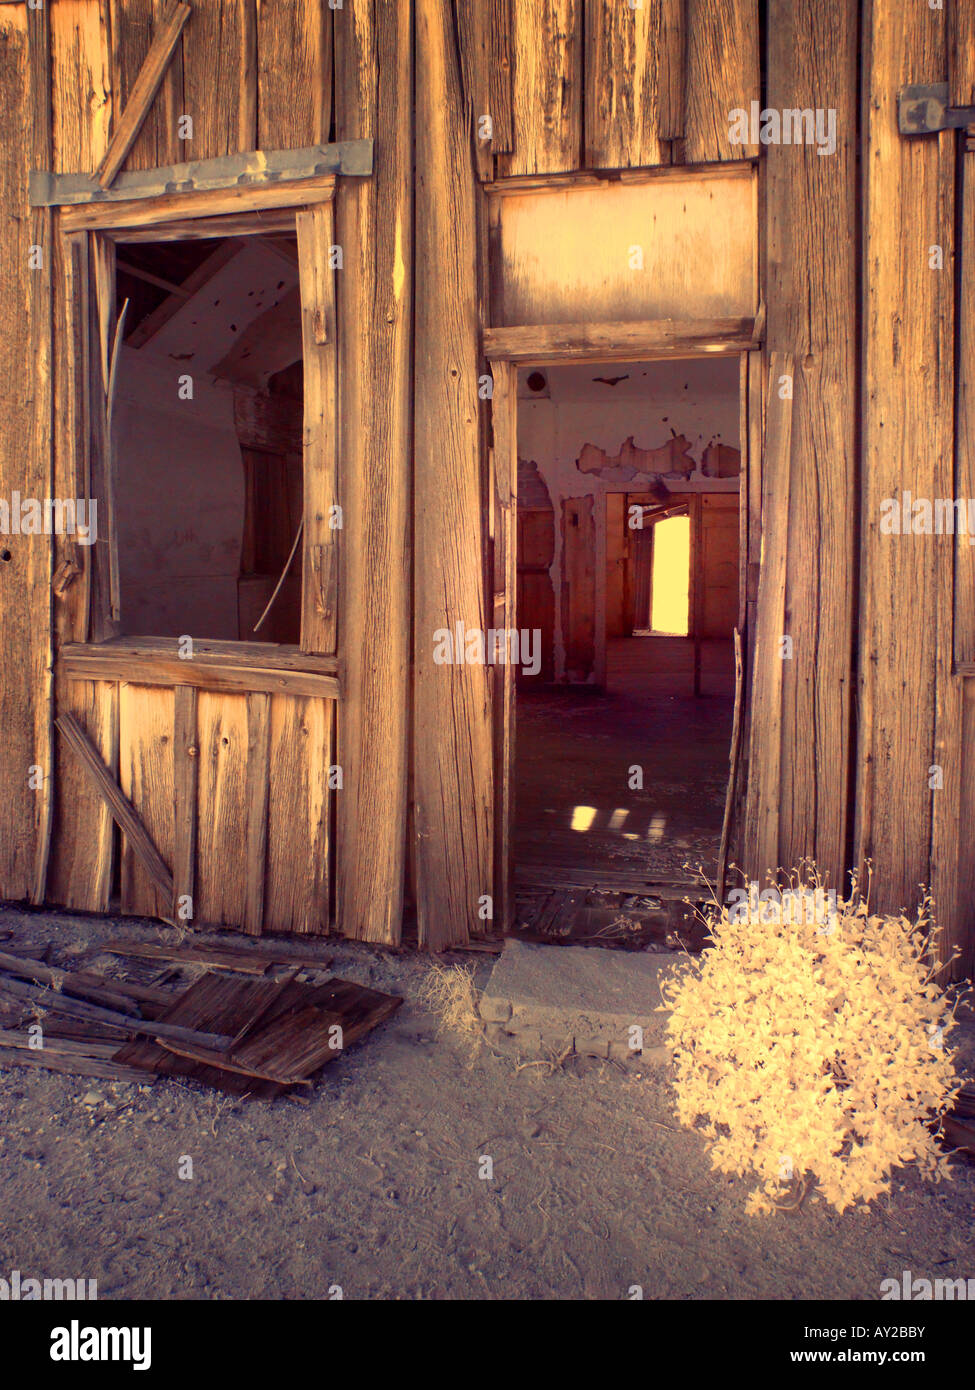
[{"left": 515, "top": 637, "right": 734, "bottom": 894}]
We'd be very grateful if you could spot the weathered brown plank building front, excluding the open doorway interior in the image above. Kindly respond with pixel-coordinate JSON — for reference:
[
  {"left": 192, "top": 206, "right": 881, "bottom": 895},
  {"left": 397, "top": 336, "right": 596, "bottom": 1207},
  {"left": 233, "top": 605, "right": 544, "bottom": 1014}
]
[{"left": 0, "top": 0, "right": 975, "bottom": 970}]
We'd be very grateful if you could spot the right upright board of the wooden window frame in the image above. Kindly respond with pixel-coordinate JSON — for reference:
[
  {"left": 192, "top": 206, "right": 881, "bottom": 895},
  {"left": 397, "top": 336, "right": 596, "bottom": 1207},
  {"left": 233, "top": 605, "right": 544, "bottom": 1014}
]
[{"left": 295, "top": 203, "right": 342, "bottom": 656}]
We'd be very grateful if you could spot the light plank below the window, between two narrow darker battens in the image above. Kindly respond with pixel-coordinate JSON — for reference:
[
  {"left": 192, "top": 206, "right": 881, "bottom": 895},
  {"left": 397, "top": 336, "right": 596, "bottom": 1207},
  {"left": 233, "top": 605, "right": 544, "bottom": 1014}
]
[{"left": 195, "top": 691, "right": 249, "bottom": 929}]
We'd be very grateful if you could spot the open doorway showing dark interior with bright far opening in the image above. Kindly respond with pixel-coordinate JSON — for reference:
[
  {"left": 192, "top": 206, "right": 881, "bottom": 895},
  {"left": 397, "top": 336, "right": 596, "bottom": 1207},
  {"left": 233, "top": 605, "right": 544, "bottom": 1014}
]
[{"left": 513, "top": 356, "right": 743, "bottom": 944}]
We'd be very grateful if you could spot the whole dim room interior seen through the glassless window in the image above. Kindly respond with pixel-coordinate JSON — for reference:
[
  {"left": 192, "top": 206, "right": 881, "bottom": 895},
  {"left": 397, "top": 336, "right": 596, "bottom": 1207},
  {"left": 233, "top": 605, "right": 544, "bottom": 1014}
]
[{"left": 113, "top": 235, "right": 302, "bottom": 644}]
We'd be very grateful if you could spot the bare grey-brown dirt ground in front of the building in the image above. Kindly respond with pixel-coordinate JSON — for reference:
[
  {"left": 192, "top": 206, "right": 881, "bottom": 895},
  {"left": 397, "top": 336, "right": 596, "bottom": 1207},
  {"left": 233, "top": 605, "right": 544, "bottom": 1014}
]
[{"left": 0, "top": 909, "right": 975, "bottom": 1300}]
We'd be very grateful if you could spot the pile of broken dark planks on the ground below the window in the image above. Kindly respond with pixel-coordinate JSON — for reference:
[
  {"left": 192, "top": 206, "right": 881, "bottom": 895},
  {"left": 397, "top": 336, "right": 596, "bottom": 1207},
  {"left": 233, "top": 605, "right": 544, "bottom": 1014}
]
[{"left": 0, "top": 941, "right": 402, "bottom": 1099}]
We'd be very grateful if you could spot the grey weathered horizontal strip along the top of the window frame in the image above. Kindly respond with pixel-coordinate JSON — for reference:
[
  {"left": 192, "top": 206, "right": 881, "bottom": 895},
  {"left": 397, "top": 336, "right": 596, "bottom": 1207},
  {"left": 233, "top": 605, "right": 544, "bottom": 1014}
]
[{"left": 31, "top": 140, "right": 373, "bottom": 207}]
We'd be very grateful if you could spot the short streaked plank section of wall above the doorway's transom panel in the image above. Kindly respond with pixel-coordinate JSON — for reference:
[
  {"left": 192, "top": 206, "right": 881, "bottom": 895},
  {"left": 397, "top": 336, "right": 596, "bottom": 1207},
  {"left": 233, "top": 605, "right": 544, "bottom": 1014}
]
[{"left": 456, "top": 0, "right": 759, "bottom": 178}]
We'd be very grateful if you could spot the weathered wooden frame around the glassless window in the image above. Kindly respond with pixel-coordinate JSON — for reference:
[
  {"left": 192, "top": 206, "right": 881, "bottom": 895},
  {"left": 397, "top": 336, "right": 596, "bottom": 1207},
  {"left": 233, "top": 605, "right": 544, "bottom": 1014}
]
[{"left": 57, "top": 175, "right": 341, "bottom": 698}]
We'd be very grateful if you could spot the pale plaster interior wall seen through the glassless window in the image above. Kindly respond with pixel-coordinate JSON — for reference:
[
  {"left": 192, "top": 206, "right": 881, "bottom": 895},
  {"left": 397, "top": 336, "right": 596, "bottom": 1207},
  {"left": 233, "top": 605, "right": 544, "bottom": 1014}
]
[{"left": 113, "top": 238, "right": 300, "bottom": 641}]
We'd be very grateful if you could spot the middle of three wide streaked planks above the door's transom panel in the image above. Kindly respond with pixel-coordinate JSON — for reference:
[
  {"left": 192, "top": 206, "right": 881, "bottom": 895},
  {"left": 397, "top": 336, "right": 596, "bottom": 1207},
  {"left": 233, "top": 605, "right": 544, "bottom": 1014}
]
[{"left": 584, "top": 0, "right": 669, "bottom": 168}]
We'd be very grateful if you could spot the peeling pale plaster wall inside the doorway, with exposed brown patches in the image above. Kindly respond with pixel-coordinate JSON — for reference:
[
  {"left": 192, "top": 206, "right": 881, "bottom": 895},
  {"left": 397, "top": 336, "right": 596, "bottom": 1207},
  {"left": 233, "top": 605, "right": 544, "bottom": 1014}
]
[{"left": 517, "top": 357, "right": 740, "bottom": 685}]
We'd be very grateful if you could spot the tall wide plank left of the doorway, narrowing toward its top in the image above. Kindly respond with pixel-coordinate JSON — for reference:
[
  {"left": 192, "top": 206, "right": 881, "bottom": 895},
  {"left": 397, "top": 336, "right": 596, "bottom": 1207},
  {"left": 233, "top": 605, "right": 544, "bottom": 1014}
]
[{"left": 413, "top": 0, "right": 495, "bottom": 949}]
